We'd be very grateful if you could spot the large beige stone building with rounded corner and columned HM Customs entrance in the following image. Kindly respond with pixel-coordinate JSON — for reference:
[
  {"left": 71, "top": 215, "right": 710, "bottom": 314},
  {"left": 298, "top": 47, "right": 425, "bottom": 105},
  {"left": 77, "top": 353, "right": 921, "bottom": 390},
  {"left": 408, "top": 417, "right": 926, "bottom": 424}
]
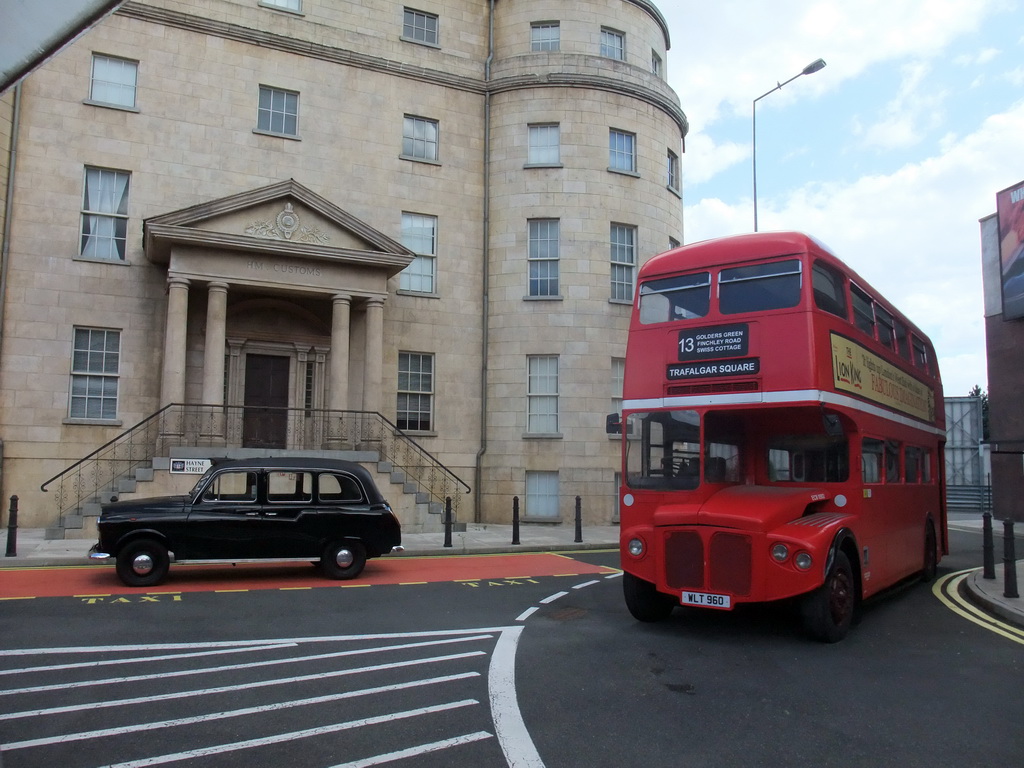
[{"left": 0, "top": 0, "right": 687, "bottom": 537}]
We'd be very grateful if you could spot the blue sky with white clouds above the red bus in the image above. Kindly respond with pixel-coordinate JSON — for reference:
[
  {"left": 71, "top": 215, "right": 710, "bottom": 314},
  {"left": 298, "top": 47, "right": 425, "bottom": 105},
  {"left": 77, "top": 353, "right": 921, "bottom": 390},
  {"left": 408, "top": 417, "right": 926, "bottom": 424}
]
[{"left": 655, "top": 0, "right": 1024, "bottom": 396}]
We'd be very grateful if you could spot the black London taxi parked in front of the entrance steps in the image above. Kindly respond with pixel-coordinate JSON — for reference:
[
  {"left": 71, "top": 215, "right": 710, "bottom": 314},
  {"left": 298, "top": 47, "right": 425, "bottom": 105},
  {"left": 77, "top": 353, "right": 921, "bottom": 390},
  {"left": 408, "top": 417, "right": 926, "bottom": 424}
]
[{"left": 89, "top": 458, "right": 401, "bottom": 587}]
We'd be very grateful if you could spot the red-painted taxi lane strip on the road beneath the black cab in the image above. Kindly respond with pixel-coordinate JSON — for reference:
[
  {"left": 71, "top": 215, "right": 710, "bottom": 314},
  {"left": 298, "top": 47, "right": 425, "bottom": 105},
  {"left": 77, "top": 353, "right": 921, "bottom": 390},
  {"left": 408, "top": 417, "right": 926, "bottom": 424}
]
[{"left": 0, "top": 552, "right": 618, "bottom": 600}]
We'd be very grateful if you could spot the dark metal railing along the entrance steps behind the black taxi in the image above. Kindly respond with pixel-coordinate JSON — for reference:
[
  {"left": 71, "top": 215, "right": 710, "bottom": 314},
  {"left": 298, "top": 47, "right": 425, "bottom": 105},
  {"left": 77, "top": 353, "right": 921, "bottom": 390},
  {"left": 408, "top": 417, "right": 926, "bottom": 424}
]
[{"left": 40, "top": 403, "right": 471, "bottom": 532}]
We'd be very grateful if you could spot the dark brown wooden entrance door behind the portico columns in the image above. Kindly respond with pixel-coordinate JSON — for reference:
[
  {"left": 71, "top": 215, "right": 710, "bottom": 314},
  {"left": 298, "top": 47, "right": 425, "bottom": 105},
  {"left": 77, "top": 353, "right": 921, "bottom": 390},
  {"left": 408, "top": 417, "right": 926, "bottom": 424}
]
[{"left": 242, "top": 354, "right": 291, "bottom": 449}]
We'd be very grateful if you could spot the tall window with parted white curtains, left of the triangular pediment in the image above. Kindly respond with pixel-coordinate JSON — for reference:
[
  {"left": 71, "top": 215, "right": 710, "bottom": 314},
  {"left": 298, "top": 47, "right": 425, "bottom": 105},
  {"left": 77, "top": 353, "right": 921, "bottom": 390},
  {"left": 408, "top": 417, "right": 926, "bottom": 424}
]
[{"left": 81, "top": 168, "right": 131, "bottom": 261}]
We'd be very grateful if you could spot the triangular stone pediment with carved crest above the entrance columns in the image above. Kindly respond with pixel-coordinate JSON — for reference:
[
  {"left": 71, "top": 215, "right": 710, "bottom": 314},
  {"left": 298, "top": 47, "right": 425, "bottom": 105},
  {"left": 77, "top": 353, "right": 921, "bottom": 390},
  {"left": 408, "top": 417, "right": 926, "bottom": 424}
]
[{"left": 143, "top": 179, "right": 414, "bottom": 273}]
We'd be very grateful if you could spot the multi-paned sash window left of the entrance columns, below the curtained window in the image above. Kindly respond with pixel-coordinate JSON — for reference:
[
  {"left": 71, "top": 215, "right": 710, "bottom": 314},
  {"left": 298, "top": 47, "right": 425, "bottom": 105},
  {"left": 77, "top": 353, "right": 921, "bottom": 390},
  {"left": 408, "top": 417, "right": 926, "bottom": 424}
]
[{"left": 69, "top": 328, "right": 121, "bottom": 419}]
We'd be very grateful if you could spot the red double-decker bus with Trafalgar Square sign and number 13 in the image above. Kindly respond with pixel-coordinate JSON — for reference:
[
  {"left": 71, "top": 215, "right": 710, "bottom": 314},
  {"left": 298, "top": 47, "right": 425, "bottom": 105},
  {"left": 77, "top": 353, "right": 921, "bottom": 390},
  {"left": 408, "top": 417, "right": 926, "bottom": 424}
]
[{"left": 609, "top": 232, "right": 948, "bottom": 642}]
